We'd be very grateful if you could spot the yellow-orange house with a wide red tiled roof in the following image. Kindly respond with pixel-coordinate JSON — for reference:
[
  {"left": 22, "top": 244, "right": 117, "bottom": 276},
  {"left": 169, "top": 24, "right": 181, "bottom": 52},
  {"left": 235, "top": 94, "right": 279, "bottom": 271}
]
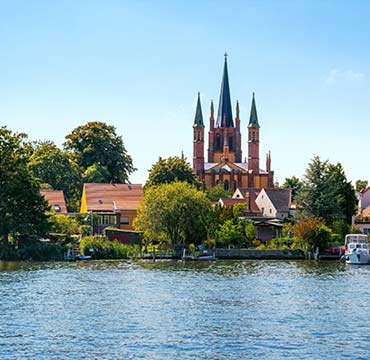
[{"left": 80, "top": 183, "right": 144, "bottom": 234}]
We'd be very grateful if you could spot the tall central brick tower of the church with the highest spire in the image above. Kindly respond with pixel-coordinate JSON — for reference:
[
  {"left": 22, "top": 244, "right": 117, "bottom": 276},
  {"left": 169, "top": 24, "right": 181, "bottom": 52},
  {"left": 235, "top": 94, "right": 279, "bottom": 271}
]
[{"left": 208, "top": 54, "right": 242, "bottom": 163}]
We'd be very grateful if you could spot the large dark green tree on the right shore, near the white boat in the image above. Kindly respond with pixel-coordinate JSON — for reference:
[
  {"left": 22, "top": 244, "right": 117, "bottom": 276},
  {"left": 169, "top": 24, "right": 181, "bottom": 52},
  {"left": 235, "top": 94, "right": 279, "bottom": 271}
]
[{"left": 298, "top": 156, "right": 356, "bottom": 225}]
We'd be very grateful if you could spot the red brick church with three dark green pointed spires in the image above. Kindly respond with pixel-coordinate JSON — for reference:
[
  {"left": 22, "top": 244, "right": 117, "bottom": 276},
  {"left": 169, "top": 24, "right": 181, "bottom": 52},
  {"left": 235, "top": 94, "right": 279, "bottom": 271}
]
[{"left": 193, "top": 54, "right": 274, "bottom": 191}]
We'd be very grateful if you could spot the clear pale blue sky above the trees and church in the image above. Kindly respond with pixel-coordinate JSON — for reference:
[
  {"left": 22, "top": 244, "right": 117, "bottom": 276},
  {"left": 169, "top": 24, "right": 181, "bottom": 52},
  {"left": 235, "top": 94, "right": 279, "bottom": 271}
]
[{"left": 0, "top": 0, "right": 370, "bottom": 183}]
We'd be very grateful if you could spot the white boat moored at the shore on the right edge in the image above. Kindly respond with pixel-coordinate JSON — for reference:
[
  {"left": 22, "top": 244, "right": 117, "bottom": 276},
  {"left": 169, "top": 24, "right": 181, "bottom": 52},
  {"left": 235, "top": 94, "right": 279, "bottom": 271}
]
[{"left": 344, "top": 234, "right": 370, "bottom": 265}]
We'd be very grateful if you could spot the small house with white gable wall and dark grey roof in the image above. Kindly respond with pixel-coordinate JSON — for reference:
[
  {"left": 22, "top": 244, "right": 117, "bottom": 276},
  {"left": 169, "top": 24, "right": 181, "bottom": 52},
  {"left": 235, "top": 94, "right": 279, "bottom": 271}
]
[{"left": 256, "top": 189, "right": 291, "bottom": 220}]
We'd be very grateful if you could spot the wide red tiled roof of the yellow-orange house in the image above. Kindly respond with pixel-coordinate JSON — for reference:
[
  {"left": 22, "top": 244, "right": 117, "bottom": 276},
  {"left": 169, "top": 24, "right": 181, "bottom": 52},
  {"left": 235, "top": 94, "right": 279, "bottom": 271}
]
[{"left": 84, "top": 183, "right": 144, "bottom": 211}]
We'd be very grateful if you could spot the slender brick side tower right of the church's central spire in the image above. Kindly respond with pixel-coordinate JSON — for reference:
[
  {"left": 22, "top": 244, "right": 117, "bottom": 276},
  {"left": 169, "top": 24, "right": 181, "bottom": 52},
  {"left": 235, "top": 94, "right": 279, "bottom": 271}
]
[{"left": 248, "top": 93, "right": 260, "bottom": 175}]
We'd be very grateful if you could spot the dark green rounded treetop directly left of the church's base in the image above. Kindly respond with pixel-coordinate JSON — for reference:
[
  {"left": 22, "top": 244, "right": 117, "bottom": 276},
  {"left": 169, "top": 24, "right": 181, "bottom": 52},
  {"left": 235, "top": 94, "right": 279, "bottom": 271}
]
[{"left": 145, "top": 156, "right": 196, "bottom": 188}]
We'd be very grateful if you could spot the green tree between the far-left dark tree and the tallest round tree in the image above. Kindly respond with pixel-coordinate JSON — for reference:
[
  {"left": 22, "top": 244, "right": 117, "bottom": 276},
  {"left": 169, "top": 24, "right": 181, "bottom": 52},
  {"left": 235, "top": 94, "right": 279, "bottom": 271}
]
[{"left": 28, "top": 141, "right": 82, "bottom": 211}]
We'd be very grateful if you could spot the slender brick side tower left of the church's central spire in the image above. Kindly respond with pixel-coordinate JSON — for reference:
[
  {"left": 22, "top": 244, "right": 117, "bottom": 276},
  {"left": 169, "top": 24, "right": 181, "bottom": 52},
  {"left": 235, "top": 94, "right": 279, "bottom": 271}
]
[{"left": 193, "top": 92, "right": 204, "bottom": 180}]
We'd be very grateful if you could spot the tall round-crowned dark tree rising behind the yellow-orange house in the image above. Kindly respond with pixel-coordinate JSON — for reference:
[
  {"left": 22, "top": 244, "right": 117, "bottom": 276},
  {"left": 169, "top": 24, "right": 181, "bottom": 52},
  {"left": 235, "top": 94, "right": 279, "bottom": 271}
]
[{"left": 64, "top": 121, "right": 136, "bottom": 183}]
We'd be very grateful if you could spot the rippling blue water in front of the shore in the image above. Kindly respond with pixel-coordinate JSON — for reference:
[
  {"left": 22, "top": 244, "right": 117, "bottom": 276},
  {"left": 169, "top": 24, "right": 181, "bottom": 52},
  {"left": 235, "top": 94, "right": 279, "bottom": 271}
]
[{"left": 0, "top": 261, "right": 370, "bottom": 359}]
